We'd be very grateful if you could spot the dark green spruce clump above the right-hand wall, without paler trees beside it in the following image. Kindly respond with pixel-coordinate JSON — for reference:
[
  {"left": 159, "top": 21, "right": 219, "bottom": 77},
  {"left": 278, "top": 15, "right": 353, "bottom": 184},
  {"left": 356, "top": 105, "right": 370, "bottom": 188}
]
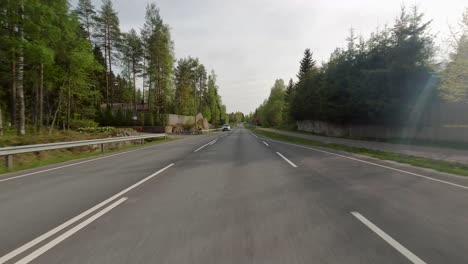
[{"left": 284, "top": 5, "right": 433, "bottom": 126}]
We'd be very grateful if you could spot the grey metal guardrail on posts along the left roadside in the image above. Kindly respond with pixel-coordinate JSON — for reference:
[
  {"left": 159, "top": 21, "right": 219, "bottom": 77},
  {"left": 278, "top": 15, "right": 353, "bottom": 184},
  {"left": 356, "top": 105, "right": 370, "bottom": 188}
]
[{"left": 0, "top": 134, "right": 166, "bottom": 168}]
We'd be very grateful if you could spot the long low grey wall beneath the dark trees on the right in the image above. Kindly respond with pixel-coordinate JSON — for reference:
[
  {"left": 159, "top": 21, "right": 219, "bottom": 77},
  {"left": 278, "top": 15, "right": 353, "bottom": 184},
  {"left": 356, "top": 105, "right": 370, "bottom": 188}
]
[{"left": 297, "top": 120, "right": 468, "bottom": 143}]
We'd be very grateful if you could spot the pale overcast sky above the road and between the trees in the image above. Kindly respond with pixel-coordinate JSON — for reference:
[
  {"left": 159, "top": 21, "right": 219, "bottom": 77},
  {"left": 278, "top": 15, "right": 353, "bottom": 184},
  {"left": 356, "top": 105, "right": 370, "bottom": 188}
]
[{"left": 72, "top": 0, "right": 468, "bottom": 113}]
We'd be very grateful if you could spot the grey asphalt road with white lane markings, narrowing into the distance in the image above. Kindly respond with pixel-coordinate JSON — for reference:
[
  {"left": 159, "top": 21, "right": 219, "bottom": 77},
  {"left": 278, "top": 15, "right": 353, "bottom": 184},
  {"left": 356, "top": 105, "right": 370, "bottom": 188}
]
[{"left": 0, "top": 128, "right": 468, "bottom": 264}]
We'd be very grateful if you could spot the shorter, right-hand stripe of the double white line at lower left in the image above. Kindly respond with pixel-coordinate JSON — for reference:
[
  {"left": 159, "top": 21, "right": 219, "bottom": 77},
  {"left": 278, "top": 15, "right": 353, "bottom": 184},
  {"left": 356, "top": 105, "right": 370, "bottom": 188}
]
[{"left": 16, "top": 197, "right": 127, "bottom": 264}]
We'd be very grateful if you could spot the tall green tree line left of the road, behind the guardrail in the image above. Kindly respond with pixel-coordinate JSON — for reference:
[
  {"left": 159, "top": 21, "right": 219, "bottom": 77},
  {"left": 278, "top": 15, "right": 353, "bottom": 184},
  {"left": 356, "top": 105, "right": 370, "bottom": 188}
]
[{"left": 0, "top": 0, "right": 228, "bottom": 135}]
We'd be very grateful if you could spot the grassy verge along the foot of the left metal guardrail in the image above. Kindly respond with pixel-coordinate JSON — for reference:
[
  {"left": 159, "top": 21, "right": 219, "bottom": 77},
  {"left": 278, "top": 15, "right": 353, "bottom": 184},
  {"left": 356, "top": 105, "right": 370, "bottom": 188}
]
[{"left": 0, "top": 138, "right": 175, "bottom": 174}]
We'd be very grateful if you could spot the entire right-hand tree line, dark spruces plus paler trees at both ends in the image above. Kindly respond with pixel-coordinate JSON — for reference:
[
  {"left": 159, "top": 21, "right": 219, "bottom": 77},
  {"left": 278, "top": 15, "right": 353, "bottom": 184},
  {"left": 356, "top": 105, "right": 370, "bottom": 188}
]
[{"left": 254, "top": 7, "right": 468, "bottom": 126}]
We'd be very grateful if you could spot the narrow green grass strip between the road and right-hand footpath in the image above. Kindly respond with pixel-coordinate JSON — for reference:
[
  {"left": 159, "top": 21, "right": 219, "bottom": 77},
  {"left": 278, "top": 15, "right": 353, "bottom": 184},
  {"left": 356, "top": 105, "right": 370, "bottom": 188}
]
[{"left": 248, "top": 127, "right": 468, "bottom": 176}]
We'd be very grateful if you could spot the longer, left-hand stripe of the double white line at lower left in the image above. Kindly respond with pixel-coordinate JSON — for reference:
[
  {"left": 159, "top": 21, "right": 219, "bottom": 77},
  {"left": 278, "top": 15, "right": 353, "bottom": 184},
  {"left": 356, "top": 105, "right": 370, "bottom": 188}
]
[{"left": 0, "top": 163, "right": 174, "bottom": 264}]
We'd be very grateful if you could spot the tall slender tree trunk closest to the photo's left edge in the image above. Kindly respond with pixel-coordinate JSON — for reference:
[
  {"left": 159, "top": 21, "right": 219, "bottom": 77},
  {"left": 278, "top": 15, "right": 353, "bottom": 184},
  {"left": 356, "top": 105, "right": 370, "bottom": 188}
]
[{"left": 17, "top": 2, "right": 26, "bottom": 136}]
